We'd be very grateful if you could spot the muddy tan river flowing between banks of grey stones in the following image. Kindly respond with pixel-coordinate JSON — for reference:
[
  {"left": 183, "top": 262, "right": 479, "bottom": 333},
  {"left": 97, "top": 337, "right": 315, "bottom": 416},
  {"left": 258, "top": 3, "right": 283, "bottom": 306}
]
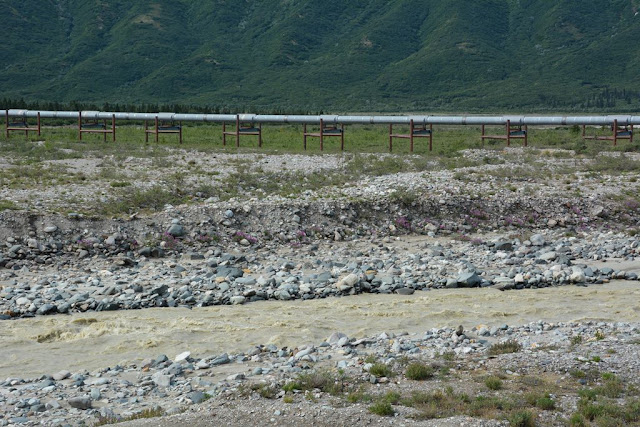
[{"left": 0, "top": 281, "right": 640, "bottom": 378}]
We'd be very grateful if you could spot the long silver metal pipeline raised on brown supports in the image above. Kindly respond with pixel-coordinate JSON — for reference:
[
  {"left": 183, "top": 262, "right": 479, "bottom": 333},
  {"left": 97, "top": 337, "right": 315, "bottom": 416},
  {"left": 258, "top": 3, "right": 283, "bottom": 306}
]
[{"left": 0, "top": 109, "right": 640, "bottom": 126}]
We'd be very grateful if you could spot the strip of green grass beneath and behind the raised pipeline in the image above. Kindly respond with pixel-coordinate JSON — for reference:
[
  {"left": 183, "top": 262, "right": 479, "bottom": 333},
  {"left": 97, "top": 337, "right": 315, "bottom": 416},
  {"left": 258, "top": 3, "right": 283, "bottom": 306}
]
[{"left": 0, "top": 123, "right": 637, "bottom": 161}]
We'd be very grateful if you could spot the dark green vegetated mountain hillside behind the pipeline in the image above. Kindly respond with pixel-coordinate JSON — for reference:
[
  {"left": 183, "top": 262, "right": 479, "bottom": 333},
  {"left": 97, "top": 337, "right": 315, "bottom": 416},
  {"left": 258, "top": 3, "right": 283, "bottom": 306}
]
[{"left": 0, "top": 0, "right": 640, "bottom": 111}]
